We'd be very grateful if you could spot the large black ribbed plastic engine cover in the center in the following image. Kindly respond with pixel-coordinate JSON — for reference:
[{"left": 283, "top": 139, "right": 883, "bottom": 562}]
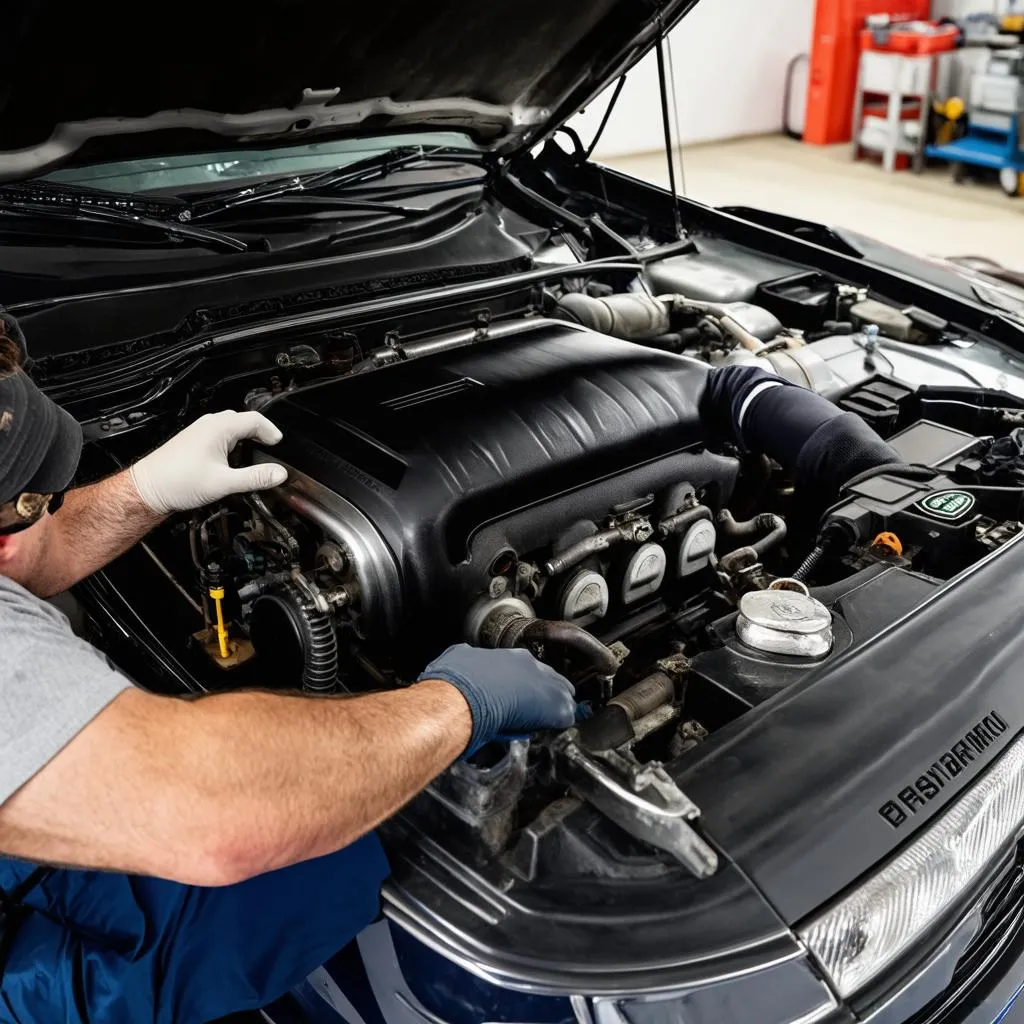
[{"left": 264, "top": 322, "right": 736, "bottom": 648}]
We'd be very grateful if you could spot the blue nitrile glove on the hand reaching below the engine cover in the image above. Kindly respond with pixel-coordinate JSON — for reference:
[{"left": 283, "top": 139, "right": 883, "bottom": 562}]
[{"left": 420, "top": 643, "right": 575, "bottom": 758}]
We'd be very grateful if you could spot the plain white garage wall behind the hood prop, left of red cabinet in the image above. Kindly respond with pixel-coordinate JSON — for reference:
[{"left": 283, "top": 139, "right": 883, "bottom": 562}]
[{"left": 570, "top": 0, "right": 815, "bottom": 157}]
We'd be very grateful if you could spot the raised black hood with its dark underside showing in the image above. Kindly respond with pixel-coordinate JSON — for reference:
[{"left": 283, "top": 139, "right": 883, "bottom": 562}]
[{"left": 0, "top": 0, "right": 696, "bottom": 181}]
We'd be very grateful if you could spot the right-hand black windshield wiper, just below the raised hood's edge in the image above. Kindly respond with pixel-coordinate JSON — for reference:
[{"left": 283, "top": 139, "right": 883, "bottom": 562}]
[{"left": 184, "top": 145, "right": 481, "bottom": 222}]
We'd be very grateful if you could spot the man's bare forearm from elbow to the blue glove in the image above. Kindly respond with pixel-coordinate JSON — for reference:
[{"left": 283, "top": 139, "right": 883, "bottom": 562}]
[{"left": 182, "top": 680, "right": 472, "bottom": 877}]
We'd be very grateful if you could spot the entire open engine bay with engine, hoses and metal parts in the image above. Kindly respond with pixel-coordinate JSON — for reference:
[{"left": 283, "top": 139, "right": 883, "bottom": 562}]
[{"left": 32, "top": 146, "right": 1024, "bottom": 888}]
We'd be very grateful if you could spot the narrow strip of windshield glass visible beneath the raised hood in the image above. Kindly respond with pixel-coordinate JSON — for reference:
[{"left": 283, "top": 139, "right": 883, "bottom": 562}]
[{"left": 40, "top": 132, "right": 478, "bottom": 193}]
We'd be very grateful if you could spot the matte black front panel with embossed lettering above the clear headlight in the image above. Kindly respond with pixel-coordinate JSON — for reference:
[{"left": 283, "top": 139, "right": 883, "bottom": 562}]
[{"left": 675, "top": 543, "right": 1024, "bottom": 924}]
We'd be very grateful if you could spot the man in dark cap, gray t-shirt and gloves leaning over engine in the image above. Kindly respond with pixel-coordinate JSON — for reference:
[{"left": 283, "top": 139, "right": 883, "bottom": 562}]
[{"left": 0, "top": 308, "right": 575, "bottom": 1024}]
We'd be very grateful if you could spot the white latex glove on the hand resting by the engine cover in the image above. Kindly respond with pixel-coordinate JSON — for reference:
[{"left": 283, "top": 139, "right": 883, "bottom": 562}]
[{"left": 131, "top": 410, "right": 288, "bottom": 515}]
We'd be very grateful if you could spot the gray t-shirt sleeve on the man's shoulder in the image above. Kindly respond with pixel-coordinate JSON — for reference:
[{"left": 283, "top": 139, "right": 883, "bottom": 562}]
[{"left": 0, "top": 577, "right": 132, "bottom": 804}]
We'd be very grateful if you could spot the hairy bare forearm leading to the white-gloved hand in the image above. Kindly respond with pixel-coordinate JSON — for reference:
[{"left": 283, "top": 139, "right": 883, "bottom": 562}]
[{"left": 33, "top": 471, "right": 163, "bottom": 597}]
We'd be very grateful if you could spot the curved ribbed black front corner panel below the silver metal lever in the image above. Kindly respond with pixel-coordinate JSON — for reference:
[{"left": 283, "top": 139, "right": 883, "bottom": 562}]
[{"left": 384, "top": 807, "right": 801, "bottom": 993}]
